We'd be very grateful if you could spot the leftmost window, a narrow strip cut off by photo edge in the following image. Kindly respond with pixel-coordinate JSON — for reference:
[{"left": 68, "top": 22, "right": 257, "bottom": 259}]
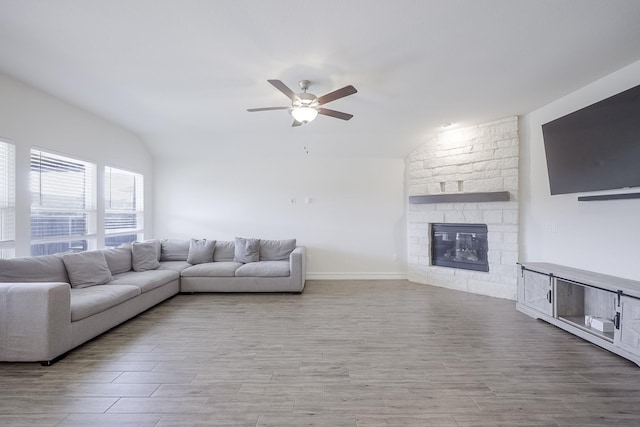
[{"left": 0, "top": 141, "right": 16, "bottom": 258}]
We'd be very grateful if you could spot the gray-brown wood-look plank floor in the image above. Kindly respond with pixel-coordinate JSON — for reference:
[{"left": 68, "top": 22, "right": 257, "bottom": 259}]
[{"left": 0, "top": 280, "right": 640, "bottom": 427}]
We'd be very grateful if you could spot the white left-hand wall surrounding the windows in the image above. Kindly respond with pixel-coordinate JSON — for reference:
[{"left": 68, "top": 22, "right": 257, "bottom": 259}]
[{"left": 0, "top": 74, "right": 153, "bottom": 256}]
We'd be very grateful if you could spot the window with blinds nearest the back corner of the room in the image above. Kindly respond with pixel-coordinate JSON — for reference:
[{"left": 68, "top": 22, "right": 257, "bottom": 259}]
[{"left": 104, "top": 167, "right": 144, "bottom": 247}]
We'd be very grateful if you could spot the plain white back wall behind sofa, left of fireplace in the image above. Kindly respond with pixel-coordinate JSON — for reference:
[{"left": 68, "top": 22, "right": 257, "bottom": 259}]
[{"left": 154, "top": 154, "right": 406, "bottom": 279}]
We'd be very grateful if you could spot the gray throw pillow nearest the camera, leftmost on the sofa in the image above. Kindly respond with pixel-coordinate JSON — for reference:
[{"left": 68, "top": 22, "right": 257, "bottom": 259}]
[{"left": 62, "top": 251, "right": 113, "bottom": 288}]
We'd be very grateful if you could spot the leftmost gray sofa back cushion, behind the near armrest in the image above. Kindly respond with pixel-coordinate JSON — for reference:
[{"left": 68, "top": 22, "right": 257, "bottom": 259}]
[{"left": 0, "top": 255, "right": 69, "bottom": 283}]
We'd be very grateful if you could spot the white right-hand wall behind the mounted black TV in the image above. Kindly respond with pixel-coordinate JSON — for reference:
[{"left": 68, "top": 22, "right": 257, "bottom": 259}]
[{"left": 520, "top": 61, "right": 640, "bottom": 280}]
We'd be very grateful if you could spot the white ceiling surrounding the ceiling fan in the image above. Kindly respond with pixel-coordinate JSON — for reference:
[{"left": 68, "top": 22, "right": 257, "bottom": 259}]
[{"left": 0, "top": 0, "right": 640, "bottom": 158}]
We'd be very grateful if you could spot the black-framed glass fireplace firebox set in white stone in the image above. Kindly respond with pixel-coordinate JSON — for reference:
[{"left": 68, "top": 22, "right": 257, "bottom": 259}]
[{"left": 431, "top": 224, "right": 489, "bottom": 271}]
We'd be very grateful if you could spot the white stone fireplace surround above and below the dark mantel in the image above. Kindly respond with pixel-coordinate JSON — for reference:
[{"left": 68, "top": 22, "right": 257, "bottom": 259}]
[{"left": 406, "top": 117, "right": 519, "bottom": 299}]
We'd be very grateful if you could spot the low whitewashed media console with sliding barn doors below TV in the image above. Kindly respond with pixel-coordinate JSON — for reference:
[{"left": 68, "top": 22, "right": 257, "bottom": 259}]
[{"left": 516, "top": 262, "right": 640, "bottom": 365}]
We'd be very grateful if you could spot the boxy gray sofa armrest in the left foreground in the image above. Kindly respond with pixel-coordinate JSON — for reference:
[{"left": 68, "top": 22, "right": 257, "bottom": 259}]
[{"left": 0, "top": 282, "right": 71, "bottom": 362}]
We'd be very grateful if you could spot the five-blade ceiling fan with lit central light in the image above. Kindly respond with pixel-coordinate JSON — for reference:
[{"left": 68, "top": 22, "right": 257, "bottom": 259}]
[{"left": 247, "top": 80, "right": 358, "bottom": 127}]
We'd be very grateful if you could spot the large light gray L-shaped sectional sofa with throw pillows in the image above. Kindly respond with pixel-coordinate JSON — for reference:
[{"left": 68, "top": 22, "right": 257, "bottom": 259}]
[{"left": 0, "top": 238, "right": 306, "bottom": 365}]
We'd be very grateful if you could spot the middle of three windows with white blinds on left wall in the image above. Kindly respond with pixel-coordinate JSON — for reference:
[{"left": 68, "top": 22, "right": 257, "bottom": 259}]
[{"left": 31, "top": 150, "right": 96, "bottom": 255}]
